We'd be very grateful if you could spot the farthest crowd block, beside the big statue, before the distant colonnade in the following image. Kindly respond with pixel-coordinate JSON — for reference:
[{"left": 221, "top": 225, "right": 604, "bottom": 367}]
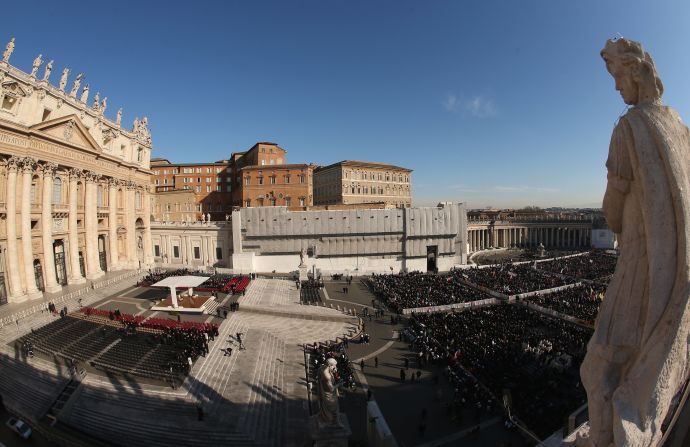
[{"left": 537, "top": 250, "right": 618, "bottom": 282}]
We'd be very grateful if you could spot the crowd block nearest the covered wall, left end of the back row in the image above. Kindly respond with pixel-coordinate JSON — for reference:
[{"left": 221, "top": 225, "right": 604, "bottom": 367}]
[{"left": 369, "top": 270, "right": 491, "bottom": 313}]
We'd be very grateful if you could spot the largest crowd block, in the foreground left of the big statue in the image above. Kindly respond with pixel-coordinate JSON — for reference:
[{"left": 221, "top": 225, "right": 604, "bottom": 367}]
[{"left": 408, "top": 304, "right": 591, "bottom": 437}]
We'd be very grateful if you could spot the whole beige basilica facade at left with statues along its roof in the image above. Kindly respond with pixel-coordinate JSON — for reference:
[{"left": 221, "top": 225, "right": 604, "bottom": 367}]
[{"left": 0, "top": 39, "right": 153, "bottom": 303}]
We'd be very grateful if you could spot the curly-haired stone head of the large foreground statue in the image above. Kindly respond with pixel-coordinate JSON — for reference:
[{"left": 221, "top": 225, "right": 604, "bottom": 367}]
[{"left": 600, "top": 39, "right": 664, "bottom": 105}]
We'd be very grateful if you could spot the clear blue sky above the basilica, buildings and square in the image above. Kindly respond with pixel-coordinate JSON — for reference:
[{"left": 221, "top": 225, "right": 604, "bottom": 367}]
[{"left": 0, "top": 0, "right": 690, "bottom": 207}]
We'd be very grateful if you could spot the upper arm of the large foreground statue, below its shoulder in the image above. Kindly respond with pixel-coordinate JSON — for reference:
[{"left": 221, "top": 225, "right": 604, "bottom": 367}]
[{"left": 602, "top": 118, "right": 634, "bottom": 234}]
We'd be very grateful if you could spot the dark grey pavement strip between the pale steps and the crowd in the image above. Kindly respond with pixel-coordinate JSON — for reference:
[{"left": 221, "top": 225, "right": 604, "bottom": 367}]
[{"left": 325, "top": 278, "right": 530, "bottom": 447}]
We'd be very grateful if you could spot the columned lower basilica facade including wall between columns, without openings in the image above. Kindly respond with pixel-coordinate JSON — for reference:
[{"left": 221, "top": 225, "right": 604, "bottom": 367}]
[{"left": 4, "top": 156, "right": 152, "bottom": 302}]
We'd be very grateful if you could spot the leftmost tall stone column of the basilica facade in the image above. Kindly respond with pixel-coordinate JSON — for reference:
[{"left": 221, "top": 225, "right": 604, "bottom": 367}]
[{"left": 5, "top": 157, "right": 28, "bottom": 303}]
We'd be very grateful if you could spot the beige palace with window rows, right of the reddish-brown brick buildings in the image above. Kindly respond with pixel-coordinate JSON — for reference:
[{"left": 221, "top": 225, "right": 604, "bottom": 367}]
[{"left": 314, "top": 160, "right": 412, "bottom": 208}]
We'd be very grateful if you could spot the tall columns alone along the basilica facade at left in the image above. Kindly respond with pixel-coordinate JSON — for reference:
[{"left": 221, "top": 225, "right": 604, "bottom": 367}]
[{"left": 5, "top": 156, "right": 152, "bottom": 302}]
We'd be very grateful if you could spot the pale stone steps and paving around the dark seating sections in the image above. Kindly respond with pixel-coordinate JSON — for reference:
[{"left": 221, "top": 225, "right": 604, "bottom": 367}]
[{"left": 2, "top": 279, "right": 357, "bottom": 446}]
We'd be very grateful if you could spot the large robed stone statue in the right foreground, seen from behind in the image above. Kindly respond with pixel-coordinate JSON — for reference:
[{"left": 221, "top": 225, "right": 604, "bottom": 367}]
[{"left": 578, "top": 39, "right": 690, "bottom": 447}]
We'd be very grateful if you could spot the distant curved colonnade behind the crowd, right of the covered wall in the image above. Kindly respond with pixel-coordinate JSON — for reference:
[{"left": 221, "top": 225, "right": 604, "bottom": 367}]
[{"left": 467, "top": 227, "right": 591, "bottom": 252}]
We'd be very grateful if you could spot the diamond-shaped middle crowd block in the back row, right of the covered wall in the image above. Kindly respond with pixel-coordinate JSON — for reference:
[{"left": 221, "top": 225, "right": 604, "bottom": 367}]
[{"left": 455, "top": 264, "right": 573, "bottom": 295}]
